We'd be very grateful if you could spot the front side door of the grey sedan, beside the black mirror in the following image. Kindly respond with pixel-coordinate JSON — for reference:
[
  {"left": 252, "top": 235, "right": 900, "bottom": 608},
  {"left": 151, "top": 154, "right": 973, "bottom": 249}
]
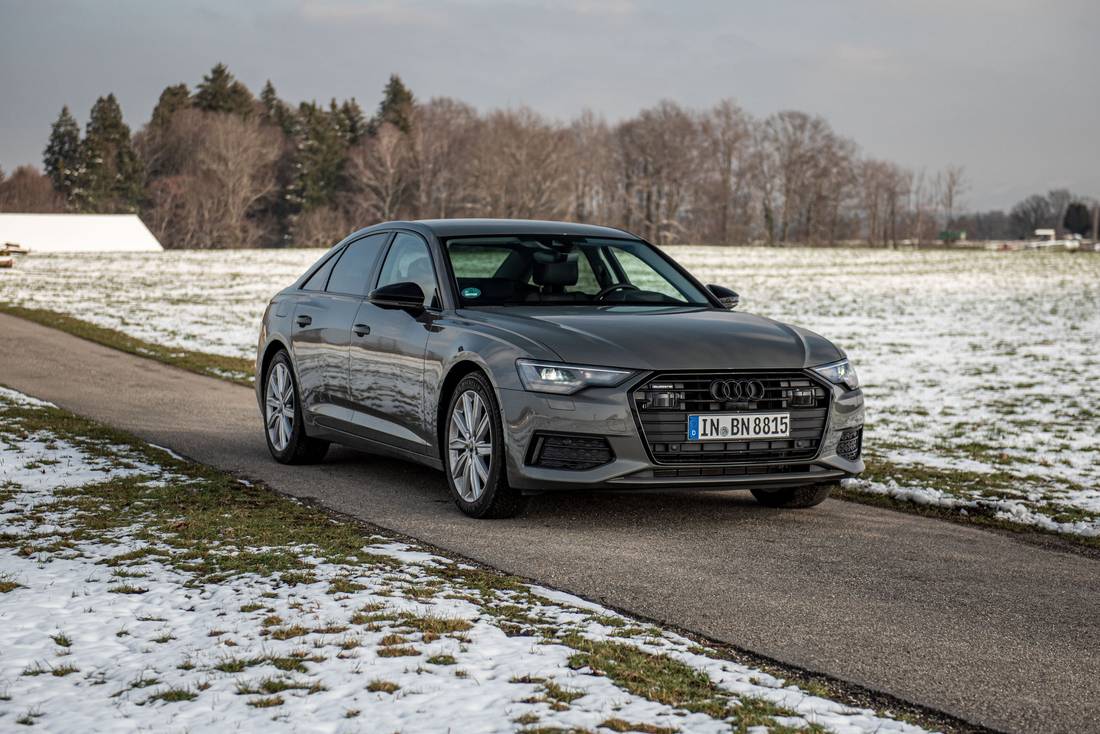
[{"left": 349, "top": 231, "right": 440, "bottom": 453}]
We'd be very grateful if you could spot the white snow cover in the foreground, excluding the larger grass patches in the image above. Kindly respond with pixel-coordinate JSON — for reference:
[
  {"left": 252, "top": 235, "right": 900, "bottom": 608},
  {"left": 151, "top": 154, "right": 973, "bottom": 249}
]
[{"left": 0, "top": 387, "right": 922, "bottom": 734}]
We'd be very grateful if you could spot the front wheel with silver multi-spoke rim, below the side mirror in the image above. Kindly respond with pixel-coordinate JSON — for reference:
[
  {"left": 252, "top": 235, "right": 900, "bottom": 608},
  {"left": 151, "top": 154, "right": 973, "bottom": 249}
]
[{"left": 442, "top": 372, "right": 525, "bottom": 519}]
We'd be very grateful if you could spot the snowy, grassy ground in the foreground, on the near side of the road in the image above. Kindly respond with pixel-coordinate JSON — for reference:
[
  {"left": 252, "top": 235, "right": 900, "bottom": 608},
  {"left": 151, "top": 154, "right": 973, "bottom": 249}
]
[{"left": 0, "top": 388, "right": 923, "bottom": 733}]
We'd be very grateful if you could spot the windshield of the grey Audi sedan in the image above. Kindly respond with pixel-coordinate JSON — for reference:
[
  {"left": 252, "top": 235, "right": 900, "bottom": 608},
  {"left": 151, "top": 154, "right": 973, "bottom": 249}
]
[{"left": 444, "top": 235, "right": 711, "bottom": 306}]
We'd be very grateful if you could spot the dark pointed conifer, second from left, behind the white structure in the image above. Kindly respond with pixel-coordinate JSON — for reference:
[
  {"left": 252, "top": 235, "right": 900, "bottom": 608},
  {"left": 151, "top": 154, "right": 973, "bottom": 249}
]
[{"left": 73, "top": 95, "right": 143, "bottom": 212}]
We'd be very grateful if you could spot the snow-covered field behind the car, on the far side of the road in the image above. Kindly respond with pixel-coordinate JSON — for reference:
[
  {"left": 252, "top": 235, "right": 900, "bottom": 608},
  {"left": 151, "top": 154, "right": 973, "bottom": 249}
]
[{"left": 0, "top": 247, "right": 1100, "bottom": 534}]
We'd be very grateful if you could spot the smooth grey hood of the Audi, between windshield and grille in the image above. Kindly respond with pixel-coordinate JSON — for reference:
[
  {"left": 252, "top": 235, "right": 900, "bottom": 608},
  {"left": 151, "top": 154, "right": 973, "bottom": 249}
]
[{"left": 460, "top": 306, "right": 844, "bottom": 370}]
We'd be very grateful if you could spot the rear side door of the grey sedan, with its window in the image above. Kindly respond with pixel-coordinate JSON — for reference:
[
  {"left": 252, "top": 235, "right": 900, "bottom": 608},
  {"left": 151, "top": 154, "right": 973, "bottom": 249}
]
[{"left": 290, "top": 232, "right": 391, "bottom": 428}]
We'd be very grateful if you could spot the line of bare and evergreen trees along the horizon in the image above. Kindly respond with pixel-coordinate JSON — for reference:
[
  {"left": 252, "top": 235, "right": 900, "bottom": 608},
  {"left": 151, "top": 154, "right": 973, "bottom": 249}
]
[{"left": 0, "top": 64, "right": 1089, "bottom": 248}]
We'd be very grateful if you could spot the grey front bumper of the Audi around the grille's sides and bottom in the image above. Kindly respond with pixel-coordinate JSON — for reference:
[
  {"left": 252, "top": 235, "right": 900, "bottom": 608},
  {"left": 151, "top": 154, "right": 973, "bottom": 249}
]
[{"left": 498, "top": 376, "right": 864, "bottom": 491}]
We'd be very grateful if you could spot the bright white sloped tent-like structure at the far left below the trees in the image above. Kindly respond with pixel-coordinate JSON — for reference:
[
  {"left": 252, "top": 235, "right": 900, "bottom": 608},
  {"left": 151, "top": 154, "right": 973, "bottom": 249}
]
[{"left": 0, "top": 213, "right": 164, "bottom": 253}]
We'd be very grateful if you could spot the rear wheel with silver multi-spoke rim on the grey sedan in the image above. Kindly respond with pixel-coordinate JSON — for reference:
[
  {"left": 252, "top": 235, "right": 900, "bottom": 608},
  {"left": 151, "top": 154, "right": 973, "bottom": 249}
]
[{"left": 264, "top": 351, "right": 329, "bottom": 464}]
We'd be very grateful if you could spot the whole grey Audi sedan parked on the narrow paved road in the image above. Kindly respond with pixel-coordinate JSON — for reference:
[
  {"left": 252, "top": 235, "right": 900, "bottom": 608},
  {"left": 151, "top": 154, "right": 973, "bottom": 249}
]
[{"left": 256, "top": 219, "right": 864, "bottom": 517}]
